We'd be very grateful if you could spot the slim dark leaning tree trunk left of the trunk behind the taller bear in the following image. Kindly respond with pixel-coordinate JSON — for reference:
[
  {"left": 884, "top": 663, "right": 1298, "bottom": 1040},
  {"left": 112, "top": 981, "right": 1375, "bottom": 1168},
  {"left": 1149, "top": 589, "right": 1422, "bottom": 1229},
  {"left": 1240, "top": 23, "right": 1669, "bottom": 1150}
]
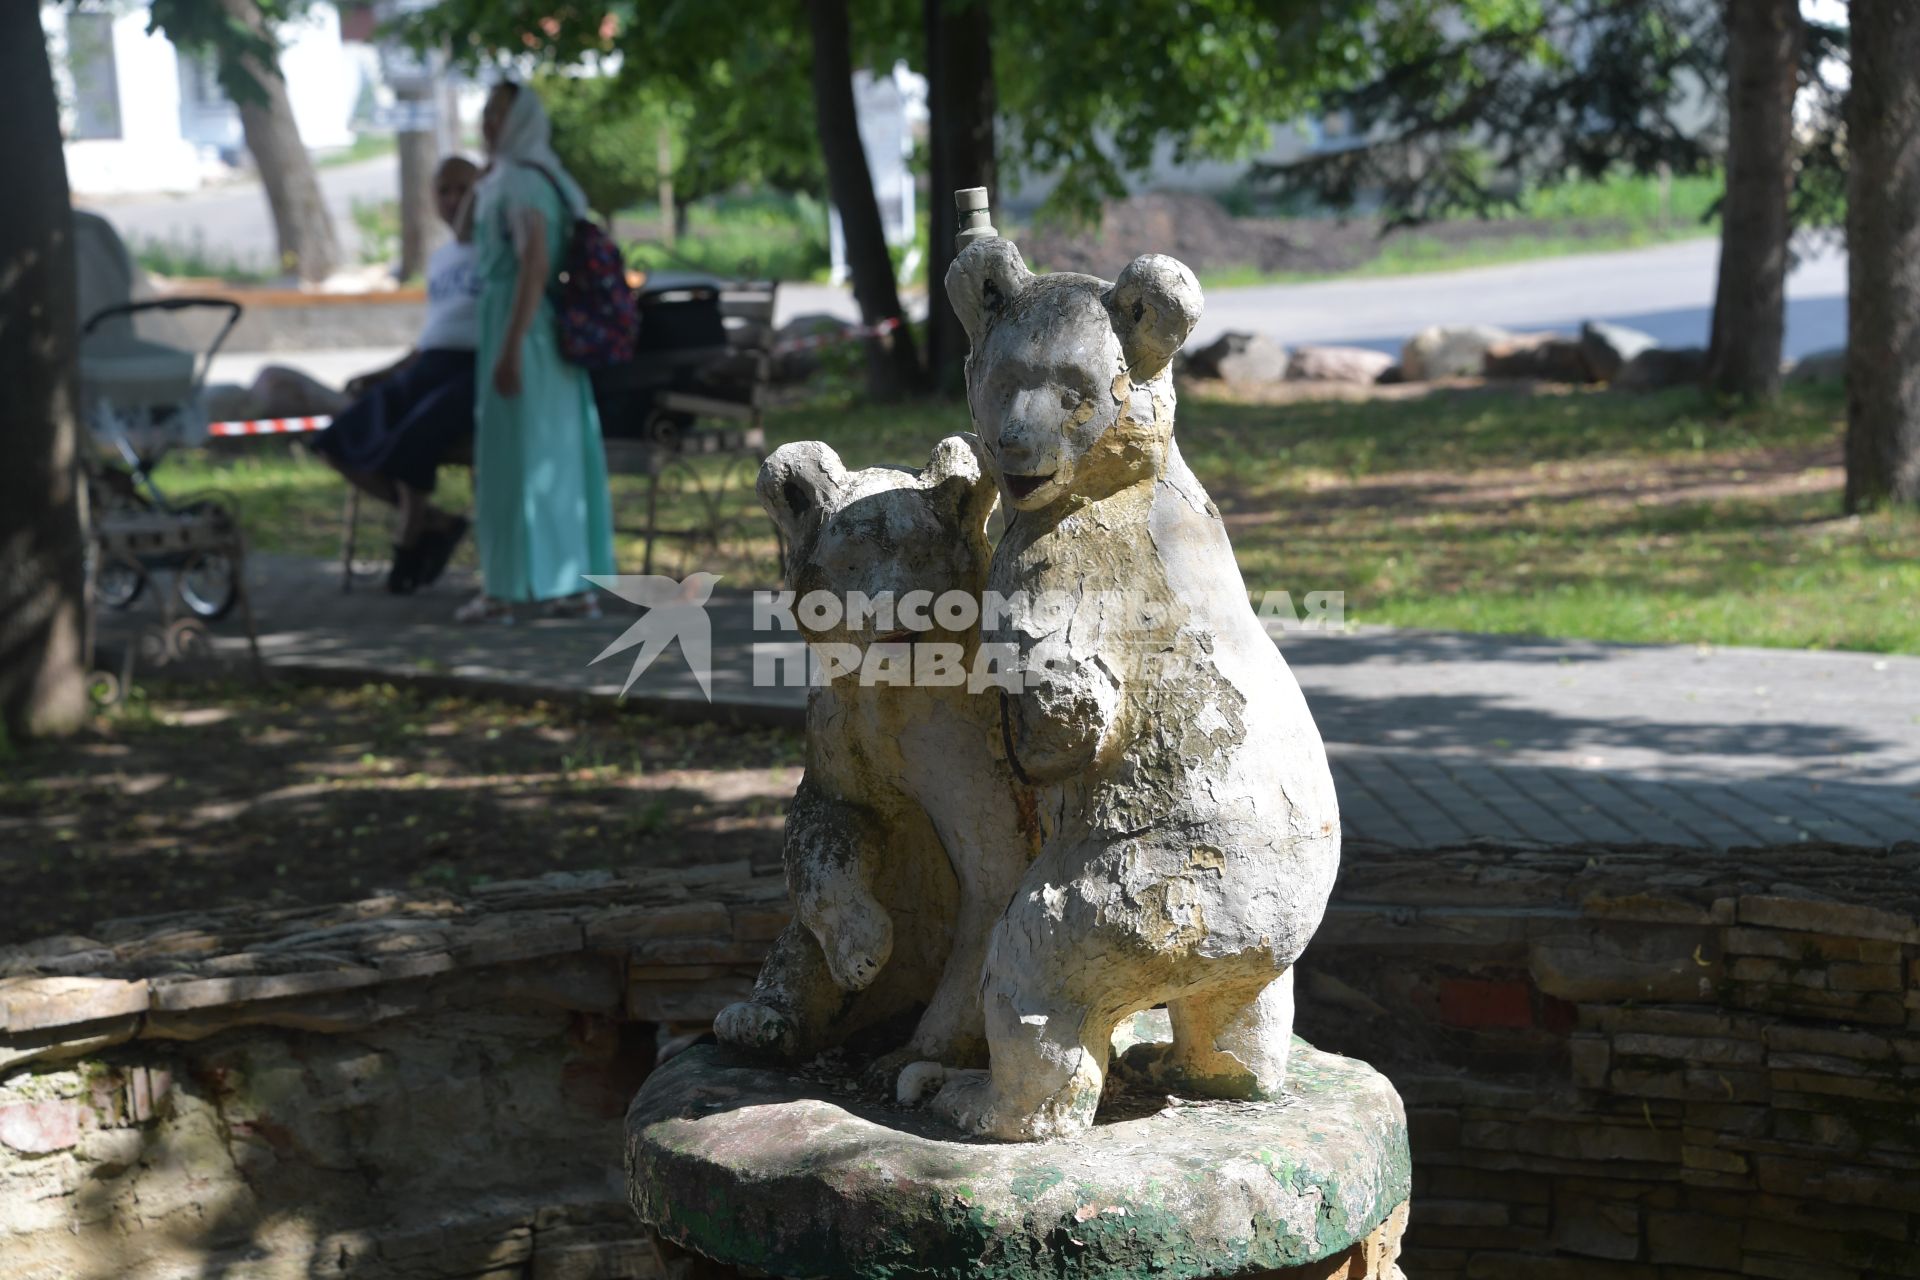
[{"left": 806, "top": 0, "right": 924, "bottom": 399}]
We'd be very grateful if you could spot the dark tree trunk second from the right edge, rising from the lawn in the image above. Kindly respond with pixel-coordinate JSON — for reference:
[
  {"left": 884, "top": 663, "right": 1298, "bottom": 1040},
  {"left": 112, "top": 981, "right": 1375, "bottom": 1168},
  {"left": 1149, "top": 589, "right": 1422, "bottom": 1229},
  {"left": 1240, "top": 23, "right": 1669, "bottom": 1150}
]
[{"left": 1707, "top": 0, "right": 1805, "bottom": 399}]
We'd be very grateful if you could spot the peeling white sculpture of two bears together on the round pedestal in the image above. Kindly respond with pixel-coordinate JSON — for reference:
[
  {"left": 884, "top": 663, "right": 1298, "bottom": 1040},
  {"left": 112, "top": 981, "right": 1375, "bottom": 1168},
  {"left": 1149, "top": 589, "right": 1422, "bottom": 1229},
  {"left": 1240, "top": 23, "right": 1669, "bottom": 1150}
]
[{"left": 716, "top": 222, "right": 1340, "bottom": 1140}]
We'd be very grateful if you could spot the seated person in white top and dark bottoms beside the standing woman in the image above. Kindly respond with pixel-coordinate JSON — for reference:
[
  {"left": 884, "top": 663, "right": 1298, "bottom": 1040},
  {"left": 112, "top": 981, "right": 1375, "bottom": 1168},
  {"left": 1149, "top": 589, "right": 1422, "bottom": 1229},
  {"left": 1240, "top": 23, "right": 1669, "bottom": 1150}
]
[{"left": 313, "top": 155, "right": 480, "bottom": 595}]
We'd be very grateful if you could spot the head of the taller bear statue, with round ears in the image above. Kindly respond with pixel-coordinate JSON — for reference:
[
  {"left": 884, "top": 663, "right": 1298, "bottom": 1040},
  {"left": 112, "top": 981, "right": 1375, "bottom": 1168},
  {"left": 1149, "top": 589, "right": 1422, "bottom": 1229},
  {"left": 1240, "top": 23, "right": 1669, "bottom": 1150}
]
[{"left": 947, "top": 240, "right": 1202, "bottom": 510}]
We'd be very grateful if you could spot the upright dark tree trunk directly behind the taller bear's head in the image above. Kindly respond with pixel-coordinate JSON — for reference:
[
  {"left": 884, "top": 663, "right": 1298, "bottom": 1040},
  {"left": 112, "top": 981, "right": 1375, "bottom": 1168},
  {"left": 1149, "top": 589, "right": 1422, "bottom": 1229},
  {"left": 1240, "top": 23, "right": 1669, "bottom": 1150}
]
[{"left": 922, "top": 0, "right": 996, "bottom": 391}]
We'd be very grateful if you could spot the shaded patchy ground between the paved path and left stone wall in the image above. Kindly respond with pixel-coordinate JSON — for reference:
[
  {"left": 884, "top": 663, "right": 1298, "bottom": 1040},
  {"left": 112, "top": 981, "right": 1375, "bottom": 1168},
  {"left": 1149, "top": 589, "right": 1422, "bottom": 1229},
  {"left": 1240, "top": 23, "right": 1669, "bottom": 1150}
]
[{"left": 0, "top": 681, "right": 801, "bottom": 942}]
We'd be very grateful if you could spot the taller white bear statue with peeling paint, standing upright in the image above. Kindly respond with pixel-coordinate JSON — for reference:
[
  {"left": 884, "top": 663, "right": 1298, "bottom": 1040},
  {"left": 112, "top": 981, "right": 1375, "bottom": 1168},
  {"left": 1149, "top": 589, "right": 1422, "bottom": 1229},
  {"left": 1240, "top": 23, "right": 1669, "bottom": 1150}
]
[{"left": 927, "top": 238, "right": 1340, "bottom": 1140}]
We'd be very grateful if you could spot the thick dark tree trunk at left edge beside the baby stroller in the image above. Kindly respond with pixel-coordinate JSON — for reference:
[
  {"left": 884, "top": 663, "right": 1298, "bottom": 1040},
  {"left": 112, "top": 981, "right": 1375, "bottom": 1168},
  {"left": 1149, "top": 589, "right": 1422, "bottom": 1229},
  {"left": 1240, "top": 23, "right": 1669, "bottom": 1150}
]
[{"left": 0, "top": 4, "right": 88, "bottom": 739}]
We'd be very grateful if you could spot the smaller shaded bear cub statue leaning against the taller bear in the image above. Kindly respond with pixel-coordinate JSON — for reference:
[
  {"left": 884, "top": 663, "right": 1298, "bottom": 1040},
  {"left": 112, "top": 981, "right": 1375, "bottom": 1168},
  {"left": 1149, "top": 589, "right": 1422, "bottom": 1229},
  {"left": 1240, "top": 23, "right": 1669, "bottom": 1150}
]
[{"left": 714, "top": 436, "right": 1035, "bottom": 1075}]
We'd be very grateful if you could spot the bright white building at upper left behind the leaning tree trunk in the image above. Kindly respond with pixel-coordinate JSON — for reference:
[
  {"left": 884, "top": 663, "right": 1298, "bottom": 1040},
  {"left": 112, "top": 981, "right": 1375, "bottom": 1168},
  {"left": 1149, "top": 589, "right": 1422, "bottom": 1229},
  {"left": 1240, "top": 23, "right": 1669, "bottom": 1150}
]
[{"left": 40, "top": 0, "right": 365, "bottom": 196}]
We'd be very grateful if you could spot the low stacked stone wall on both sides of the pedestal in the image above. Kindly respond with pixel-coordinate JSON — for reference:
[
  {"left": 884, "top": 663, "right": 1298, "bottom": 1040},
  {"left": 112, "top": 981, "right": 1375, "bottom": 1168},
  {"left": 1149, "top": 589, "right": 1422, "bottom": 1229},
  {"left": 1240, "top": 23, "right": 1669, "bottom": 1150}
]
[{"left": 0, "top": 844, "right": 1920, "bottom": 1280}]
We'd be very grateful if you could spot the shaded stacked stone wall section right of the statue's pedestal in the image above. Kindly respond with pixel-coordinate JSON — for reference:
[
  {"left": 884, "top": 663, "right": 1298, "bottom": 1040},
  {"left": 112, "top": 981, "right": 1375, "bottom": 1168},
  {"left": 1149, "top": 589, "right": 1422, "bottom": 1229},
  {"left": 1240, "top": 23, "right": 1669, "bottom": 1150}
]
[{"left": 1302, "top": 844, "right": 1920, "bottom": 1280}]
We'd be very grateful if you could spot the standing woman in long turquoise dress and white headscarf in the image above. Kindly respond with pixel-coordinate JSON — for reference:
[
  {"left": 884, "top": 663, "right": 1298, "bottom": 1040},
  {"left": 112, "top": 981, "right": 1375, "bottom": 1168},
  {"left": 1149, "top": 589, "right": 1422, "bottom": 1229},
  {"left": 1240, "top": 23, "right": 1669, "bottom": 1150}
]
[{"left": 455, "top": 83, "right": 614, "bottom": 622}]
